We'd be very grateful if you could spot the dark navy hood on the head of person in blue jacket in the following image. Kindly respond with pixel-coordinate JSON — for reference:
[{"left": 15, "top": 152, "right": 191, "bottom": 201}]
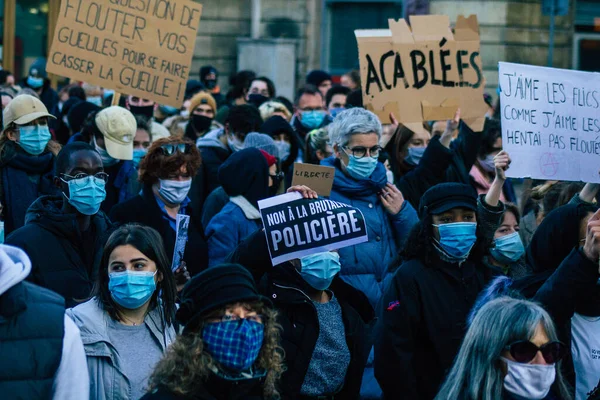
[{"left": 219, "top": 148, "right": 269, "bottom": 208}]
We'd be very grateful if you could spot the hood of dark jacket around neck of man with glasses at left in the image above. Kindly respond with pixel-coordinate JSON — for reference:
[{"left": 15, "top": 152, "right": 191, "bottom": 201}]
[{"left": 25, "top": 196, "right": 111, "bottom": 243}]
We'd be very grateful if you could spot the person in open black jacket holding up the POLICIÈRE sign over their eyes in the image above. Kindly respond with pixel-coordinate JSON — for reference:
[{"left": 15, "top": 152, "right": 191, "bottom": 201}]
[{"left": 229, "top": 200, "right": 375, "bottom": 399}]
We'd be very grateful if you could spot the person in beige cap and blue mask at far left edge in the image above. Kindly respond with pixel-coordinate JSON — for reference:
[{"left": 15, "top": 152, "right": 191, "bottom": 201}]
[{"left": 0, "top": 95, "right": 60, "bottom": 235}]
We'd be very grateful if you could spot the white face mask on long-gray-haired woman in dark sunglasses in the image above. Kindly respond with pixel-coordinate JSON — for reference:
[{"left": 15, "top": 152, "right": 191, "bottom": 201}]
[{"left": 501, "top": 357, "right": 556, "bottom": 400}]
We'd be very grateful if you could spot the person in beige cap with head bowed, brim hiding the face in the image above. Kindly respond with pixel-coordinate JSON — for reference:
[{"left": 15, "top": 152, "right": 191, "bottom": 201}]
[{"left": 84, "top": 106, "right": 137, "bottom": 214}]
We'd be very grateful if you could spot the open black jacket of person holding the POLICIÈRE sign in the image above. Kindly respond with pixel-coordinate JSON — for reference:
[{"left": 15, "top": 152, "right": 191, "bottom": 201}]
[{"left": 227, "top": 231, "right": 375, "bottom": 399}]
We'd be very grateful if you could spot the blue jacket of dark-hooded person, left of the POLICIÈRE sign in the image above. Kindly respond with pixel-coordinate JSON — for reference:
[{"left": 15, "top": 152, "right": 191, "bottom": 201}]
[{"left": 206, "top": 196, "right": 262, "bottom": 268}]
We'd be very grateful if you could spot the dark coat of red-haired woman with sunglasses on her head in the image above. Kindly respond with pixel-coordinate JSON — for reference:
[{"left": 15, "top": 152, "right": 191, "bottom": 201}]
[{"left": 110, "top": 186, "right": 208, "bottom": 275}]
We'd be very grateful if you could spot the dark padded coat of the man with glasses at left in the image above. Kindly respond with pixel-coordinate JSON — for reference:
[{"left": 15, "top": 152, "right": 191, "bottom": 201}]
[{"left": 6, "top": 196, "right": 111, "bottom": 307}]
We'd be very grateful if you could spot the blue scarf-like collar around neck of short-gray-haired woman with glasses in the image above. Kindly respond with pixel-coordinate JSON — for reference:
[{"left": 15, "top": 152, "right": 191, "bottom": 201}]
[{"left": 321, "top": 157, "right": 387, "bottom": 198}]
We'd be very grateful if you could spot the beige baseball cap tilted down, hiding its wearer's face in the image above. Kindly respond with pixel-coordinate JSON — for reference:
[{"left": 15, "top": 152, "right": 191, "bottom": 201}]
[{"left": 96, "top": 106, "right": 137, "bottom": 160}]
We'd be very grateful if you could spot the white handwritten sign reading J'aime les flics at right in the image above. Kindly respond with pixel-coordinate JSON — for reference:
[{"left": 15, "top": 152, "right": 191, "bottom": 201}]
[{"left": 500, "top": 62, "right": 600, "bottom": 183}]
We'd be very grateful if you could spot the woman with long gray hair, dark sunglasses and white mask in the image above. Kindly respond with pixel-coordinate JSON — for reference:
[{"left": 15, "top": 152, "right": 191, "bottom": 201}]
[{"left": 436, "top": 297, "right": 572, "bottom": 400}]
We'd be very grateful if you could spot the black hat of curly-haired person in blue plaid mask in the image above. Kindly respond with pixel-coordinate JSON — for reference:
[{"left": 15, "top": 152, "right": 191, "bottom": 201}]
[{"left": 176, "top": 264, "right": 270, "bottom": 332}]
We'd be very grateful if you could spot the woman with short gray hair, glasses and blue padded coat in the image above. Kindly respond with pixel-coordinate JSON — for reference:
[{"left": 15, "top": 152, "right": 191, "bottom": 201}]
[{"left": 321, "top": 108, "right": 418, "bottom": 308}]
